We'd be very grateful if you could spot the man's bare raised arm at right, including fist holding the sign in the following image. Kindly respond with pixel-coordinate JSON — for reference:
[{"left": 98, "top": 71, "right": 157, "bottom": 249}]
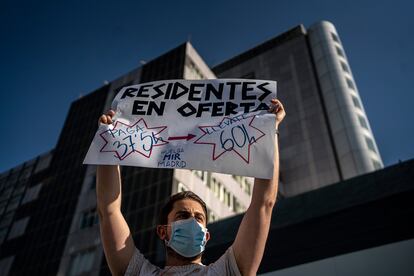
[{"left": 233, "top": 100, "right": 285, "bottom": 275}]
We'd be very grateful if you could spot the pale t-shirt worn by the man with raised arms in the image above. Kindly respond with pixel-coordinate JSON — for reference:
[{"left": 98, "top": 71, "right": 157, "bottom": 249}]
[{"left": 125, "top": 247, "right": 241, "bottom": 276}]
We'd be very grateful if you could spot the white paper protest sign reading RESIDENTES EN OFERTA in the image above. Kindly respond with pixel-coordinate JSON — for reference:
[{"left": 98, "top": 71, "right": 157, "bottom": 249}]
[{"left": 84, "top": 79, "right": 276, "bottom": 179}]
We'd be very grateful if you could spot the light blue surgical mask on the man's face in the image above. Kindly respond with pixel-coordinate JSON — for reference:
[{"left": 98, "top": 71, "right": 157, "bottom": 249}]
[{"left": 165, "top": 218, "right": 207, "bottom": 258}]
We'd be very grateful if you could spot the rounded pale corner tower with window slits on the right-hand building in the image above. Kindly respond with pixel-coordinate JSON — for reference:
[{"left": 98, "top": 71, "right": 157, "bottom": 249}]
[{"left": 309, "top": 21, "right": 383, "bottom": 179}]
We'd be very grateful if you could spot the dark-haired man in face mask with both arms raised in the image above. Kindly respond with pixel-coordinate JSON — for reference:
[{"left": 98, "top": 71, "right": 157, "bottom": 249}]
[{"left": 96, "top": 99, "right": 286, "bottom": 275}]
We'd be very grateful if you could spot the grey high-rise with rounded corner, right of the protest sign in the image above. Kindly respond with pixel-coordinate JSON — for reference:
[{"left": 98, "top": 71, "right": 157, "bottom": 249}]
[{"left": 213, "top": 21, "right": 383, "bottom": 197}]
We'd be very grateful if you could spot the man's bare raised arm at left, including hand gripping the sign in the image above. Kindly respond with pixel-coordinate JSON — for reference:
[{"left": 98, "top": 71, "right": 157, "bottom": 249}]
[{"left": 96, "top": 111, "right": 135, "bottom": 275}]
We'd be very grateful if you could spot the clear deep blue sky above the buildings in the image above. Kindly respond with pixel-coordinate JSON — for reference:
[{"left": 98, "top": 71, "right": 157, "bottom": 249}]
[{"left": 0, "top": 0, "right": 414, "bottom": 172}]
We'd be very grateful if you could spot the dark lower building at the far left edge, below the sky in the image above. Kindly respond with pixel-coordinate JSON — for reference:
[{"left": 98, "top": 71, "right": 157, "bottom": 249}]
[{"left": 0, "top": 151, "right": 53, "bottom": 275}]
